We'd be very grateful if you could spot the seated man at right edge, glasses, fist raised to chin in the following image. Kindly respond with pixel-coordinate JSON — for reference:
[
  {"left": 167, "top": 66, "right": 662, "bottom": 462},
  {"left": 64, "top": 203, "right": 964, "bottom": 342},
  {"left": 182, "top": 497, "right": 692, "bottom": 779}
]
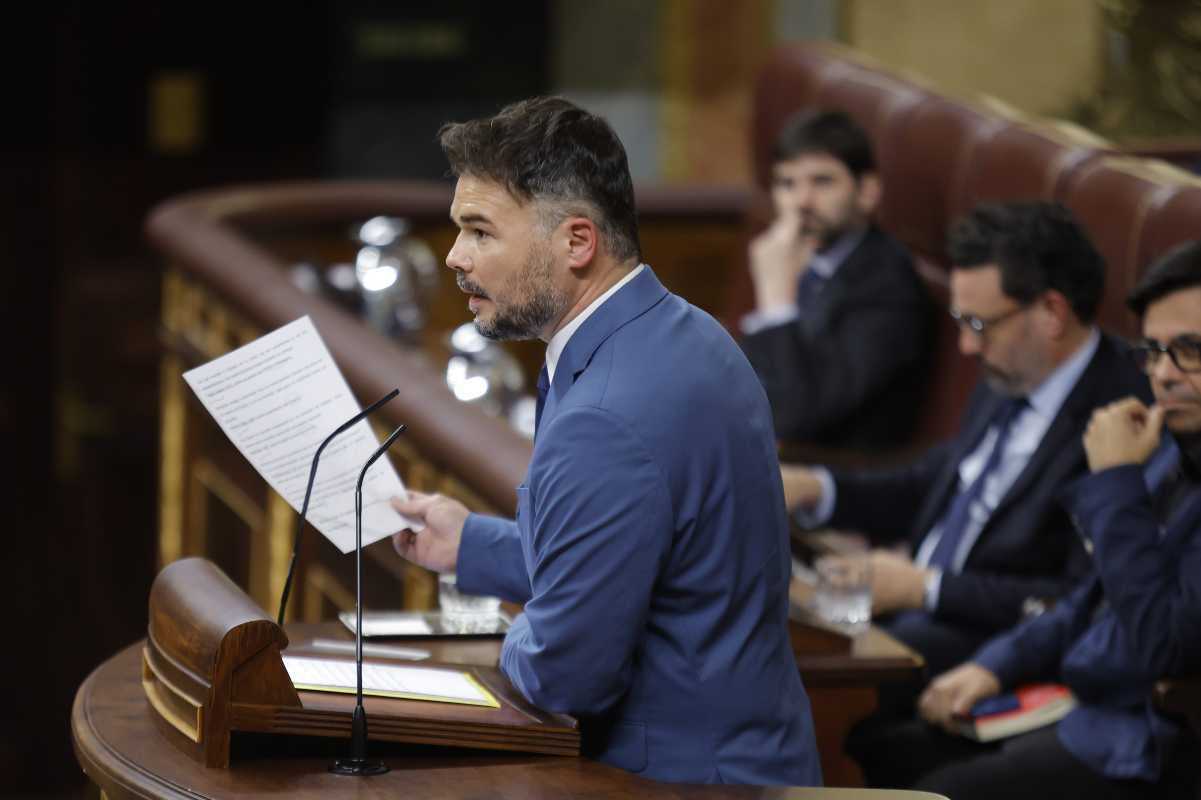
[{"left": 862, "top": 243, "right": 1201, "bottom": 800}]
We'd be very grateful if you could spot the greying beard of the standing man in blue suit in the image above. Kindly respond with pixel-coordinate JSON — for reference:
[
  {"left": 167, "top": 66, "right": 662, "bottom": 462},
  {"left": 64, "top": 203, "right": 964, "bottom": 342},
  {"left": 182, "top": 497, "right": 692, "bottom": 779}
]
[{"left": 456, "top": 236, "right": 568, "bottom": 341}]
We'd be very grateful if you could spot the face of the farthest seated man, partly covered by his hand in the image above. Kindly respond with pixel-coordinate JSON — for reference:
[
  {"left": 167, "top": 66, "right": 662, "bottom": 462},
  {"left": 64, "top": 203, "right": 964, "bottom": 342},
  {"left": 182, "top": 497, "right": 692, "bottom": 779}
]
[{"left": 771, "top": 153, "right": 876, "bottom": 247}]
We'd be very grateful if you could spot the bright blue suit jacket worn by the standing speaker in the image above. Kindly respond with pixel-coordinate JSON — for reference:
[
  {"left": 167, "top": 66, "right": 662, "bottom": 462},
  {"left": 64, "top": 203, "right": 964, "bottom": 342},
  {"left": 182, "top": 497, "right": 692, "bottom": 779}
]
[{"left": 458, "top": 268, "right": 820, "bottom": 784}]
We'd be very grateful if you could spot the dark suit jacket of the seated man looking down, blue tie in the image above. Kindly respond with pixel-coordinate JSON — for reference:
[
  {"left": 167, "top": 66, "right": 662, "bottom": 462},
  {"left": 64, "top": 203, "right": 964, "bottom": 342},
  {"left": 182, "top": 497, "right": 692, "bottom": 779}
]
[{"left": 830, "top": 335, "right": 1151, "bottom": 674}]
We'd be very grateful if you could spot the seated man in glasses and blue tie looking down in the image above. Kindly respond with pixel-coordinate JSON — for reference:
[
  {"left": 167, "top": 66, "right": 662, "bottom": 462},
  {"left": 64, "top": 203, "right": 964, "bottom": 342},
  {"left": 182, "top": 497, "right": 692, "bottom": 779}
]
[{"left": 784, "top": 203, "right": 1149, "bottom": 677}]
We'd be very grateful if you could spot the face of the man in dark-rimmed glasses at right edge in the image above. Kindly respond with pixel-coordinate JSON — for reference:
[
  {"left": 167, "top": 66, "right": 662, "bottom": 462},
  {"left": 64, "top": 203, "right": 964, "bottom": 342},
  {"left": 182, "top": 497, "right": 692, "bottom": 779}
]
[{"left": 1142, "top": 287, "right": 1201, "bottom": 434}]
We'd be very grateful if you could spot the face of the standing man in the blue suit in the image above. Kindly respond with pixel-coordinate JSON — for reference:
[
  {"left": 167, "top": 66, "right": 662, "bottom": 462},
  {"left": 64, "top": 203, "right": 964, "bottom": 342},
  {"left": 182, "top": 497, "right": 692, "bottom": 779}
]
[{"left": 447, "top": 175, "right": 568, "bottom": 340}]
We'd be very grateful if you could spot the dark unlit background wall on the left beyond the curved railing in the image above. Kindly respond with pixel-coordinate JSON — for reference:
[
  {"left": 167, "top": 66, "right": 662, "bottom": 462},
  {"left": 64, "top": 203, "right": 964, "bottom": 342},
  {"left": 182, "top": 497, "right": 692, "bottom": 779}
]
[{"left": 0, "top": 0, "right": 549, "bottom": 796}]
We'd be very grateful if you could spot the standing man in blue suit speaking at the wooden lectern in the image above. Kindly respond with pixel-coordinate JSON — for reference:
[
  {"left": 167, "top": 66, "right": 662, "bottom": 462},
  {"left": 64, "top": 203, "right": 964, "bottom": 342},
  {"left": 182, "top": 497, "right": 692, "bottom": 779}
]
[{"left": 395, "top": 98, "right": 820, "bottom": 784}]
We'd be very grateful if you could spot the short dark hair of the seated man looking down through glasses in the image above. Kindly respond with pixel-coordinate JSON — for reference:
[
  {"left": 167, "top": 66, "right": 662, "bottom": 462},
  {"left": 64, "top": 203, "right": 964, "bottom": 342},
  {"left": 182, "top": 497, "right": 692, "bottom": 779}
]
[{"left": 948, "top": 202, "right": 1105, "bottom": 322}]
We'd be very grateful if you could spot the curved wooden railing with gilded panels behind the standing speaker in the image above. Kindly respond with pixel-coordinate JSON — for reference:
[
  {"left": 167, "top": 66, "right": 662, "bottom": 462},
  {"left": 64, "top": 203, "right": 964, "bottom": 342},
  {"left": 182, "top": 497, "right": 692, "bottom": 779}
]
[{"left": 147, "top": 183, "right": 747, "bottom": 621}]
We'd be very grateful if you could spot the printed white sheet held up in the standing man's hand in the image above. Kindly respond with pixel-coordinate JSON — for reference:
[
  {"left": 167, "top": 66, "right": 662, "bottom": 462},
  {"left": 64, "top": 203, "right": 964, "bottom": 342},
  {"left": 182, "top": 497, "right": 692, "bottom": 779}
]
[{"left": 177, "top": 317, "right": 420, "bottom": 553}]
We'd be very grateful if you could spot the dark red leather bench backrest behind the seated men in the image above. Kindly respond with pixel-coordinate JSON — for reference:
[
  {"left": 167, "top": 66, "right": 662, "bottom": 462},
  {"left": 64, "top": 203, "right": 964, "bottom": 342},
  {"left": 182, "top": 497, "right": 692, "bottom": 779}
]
[{"left": 752, "top": 43, "right": 1201, "bottom": 443}]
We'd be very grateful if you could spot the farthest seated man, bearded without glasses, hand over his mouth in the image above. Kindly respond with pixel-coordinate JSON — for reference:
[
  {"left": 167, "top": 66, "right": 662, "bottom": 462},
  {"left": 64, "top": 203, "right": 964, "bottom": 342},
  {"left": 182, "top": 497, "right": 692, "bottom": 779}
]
[{"left": 742, "top": 112, "right": 932, "bottom": 449}]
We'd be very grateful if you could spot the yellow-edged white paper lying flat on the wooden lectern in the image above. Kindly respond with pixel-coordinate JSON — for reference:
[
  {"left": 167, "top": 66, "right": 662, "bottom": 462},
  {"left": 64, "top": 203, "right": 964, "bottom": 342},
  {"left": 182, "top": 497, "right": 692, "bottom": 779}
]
[{"left": 283, "top": 656, "right": 501, "bottom": 709}]
